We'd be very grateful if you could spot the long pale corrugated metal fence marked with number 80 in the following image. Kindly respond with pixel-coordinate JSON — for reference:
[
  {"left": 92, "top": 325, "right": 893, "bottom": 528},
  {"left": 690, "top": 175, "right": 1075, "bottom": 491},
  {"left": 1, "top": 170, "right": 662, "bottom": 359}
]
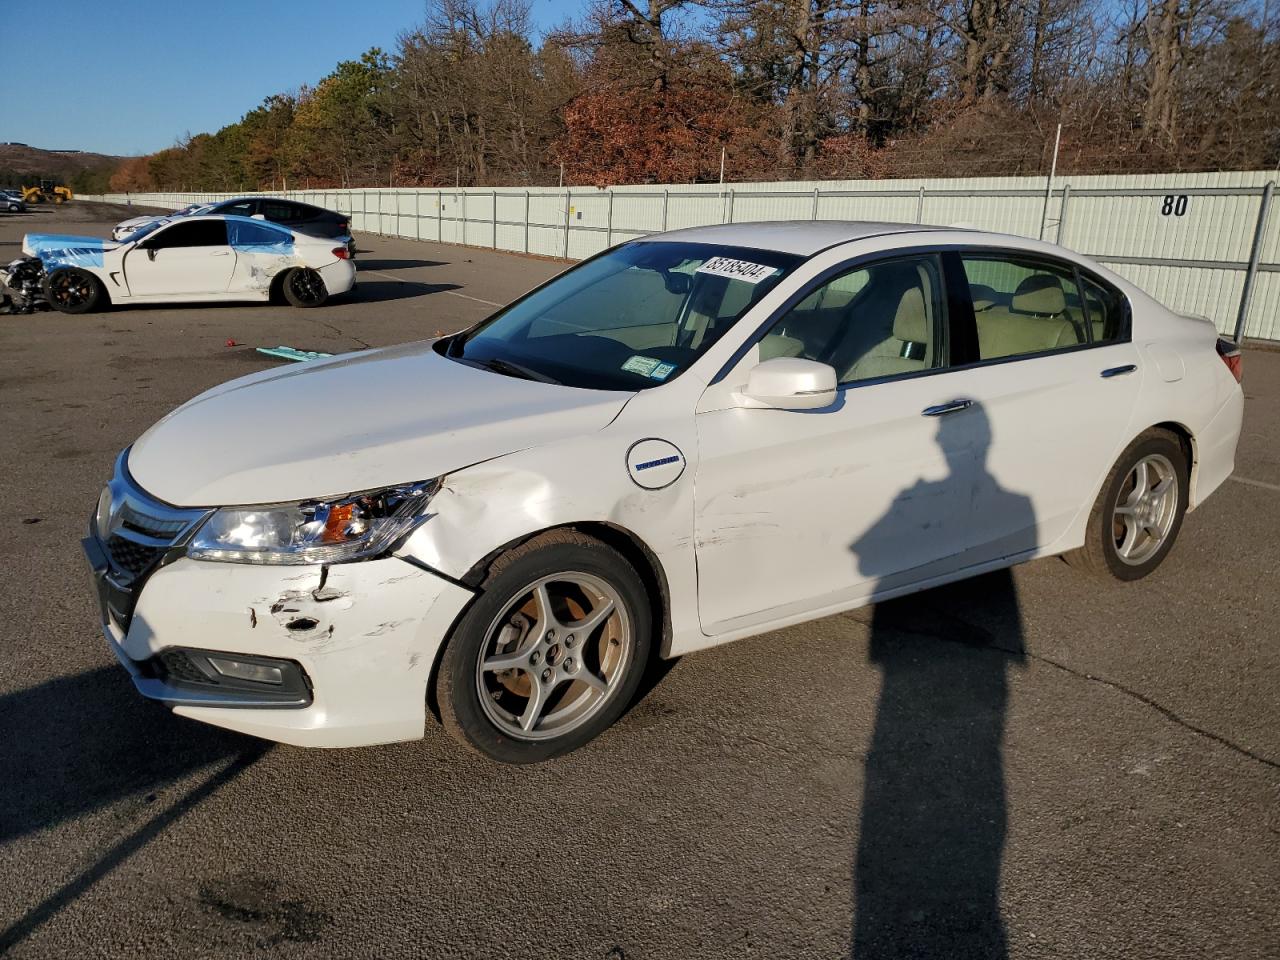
[{"left": 86, "top": 172, "right": 1280, "bottom": 340}]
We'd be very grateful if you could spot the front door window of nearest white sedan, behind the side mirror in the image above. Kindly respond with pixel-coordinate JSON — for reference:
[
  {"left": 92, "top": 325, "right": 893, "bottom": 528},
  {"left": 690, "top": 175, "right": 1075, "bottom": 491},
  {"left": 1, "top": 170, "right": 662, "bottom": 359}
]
[{"left": 760, "top": 255, "right": 946, "bottom": 383}]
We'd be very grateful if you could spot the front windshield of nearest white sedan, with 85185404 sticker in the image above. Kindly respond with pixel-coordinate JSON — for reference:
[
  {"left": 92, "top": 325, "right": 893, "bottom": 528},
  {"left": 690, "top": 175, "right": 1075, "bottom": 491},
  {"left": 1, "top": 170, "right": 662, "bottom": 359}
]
[{"left": 443, "top": 241, "right": 801, "bottom": 390}]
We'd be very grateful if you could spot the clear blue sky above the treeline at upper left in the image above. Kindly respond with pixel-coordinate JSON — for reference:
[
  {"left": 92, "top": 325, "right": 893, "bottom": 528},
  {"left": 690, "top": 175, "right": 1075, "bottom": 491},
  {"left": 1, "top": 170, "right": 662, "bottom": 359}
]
[{"left": 0, "top": 0, "right": 584, "bottom": 155}]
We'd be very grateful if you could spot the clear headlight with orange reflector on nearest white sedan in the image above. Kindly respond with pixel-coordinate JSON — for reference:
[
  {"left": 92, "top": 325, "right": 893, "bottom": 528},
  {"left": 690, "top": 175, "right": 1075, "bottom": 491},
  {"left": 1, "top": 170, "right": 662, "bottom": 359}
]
[{"left": 187, "top": 480, "right": 439, "bottom": 563}]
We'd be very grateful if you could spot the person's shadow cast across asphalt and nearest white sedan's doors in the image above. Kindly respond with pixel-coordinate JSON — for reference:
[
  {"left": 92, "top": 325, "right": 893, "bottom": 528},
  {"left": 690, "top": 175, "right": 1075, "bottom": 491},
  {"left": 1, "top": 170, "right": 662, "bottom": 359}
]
[{"left": 851, "top": 406, "right": 1036, "bottom": 960}]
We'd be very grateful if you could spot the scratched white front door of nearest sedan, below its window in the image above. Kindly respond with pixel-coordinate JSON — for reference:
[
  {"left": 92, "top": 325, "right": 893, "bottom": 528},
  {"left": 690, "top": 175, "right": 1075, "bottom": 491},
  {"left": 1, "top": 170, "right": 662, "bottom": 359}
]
[{"left": 695, "top": 371, "right": 986, "bottom": 635}]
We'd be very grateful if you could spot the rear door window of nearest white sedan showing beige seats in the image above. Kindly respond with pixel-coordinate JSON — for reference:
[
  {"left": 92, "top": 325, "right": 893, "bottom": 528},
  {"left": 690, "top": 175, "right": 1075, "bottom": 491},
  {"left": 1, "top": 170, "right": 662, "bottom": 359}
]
[{"left": 960, "top": 252, "right": 1088, "bottom": 360}]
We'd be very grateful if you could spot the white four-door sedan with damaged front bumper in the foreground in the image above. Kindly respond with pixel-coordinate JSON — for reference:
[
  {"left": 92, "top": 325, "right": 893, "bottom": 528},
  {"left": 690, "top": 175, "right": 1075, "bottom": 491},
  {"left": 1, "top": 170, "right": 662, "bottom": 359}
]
[{"left": 84, "top": 223, "right": 1243, "bottom": 763}]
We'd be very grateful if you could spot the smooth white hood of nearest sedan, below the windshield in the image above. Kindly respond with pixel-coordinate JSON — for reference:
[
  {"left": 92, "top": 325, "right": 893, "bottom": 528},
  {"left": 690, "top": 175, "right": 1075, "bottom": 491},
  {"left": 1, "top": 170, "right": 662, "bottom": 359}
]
[{"left": 128, "top": 342, "right": 634, "bottom": 507}]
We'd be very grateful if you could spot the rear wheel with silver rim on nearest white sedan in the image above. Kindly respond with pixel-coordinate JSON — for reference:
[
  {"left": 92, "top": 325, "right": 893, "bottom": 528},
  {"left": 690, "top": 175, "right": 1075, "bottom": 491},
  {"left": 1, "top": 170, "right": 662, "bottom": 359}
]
[{"left": 1064, "top": 428, "right": 1190, "bottom": 581}]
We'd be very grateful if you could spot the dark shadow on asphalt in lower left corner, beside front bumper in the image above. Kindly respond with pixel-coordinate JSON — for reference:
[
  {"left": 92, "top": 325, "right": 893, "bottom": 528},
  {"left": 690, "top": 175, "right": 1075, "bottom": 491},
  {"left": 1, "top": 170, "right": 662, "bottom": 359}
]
[{"left": 0, "top": 667, "right": 269, "bottom": 954}]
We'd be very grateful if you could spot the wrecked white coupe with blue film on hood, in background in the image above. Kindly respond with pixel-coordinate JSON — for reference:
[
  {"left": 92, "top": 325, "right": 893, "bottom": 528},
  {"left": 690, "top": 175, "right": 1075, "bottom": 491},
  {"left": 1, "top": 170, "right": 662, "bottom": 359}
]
[{"left": 22, "top": 215, "right": 356, "bottom": 314}]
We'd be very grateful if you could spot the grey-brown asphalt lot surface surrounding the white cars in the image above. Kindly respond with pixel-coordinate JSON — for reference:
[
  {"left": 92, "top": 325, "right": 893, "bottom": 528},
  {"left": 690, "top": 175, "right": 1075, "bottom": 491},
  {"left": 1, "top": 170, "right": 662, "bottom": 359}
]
[{"left": 0, "top": 202, "right": 1280, "bottom": 960}]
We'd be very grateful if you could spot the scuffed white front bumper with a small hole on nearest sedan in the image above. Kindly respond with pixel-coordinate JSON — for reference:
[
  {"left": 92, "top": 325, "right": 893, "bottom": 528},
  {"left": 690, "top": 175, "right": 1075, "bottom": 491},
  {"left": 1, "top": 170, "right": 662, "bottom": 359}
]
[{"left": 84, "top": 538, "right": 472, "bottom": 746}]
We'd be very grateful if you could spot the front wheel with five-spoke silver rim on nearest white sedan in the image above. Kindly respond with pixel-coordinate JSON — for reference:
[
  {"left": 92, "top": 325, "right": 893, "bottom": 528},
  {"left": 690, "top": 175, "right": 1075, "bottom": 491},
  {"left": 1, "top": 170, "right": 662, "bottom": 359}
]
[{"left": 436, "top": 530, "right": 653, "bottom": 764}]
